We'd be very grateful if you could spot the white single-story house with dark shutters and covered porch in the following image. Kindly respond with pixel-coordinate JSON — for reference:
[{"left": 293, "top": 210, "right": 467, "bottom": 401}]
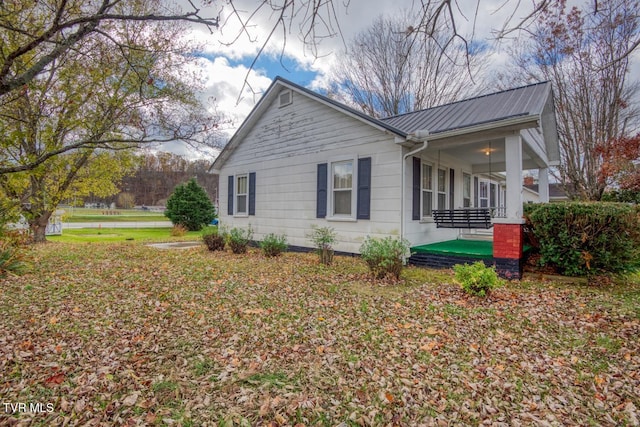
[{"left": 212, "top": 77, "right": 560, "bottom": 275}]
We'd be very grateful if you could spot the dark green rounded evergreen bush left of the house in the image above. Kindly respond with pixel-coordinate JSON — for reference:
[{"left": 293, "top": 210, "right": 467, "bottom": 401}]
[{"left": 164, "top": 179, "right": 217, "bottom": 231}]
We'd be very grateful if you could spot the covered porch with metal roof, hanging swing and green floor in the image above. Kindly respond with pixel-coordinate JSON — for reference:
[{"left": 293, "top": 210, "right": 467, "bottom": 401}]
[{"left": 384, "top": 83, "right": 560, "bottom": 278}]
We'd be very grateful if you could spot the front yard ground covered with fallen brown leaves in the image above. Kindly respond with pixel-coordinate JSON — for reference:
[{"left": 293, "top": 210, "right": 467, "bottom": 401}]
[{"left": 0, "top": 243, "right": 640, "bottom": 426}]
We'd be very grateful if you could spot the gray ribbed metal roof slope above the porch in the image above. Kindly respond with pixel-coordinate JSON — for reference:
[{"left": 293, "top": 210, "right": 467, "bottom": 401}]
[{"left": 381, "top": 82, "right": 551, "bottom": 134}]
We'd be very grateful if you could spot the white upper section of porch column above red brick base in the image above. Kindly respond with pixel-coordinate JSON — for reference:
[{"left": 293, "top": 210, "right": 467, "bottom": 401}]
[{"left": 504, "top": 133, "right": 522, "bottom": 224}]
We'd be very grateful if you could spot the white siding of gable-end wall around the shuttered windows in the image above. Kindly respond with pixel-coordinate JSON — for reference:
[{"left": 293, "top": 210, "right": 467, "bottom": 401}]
[{"left": 219, "top": 93, "right": 401, "bottom": 253}]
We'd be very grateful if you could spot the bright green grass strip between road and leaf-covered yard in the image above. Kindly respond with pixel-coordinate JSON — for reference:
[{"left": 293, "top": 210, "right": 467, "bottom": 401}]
[{"left": 47, "top": 228, "right": 212, "bottom": 243}]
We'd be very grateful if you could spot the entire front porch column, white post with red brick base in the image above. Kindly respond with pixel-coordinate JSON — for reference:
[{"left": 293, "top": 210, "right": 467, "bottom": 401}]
[{"left": 493, "top": 133, "right": 524, "bottom": 279}]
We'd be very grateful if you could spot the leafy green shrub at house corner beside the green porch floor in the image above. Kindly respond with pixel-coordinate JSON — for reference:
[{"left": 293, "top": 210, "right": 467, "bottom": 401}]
[{"left": 360, "top": 236, "right": 409, "bottom": 280}]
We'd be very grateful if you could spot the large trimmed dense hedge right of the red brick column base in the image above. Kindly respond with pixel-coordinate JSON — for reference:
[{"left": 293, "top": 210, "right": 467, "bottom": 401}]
[{"left": 525, "top": 202, "right": 640, "bottom": 276}]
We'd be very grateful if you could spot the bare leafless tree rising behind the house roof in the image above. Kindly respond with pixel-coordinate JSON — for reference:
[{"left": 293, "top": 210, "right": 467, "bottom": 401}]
[{"left": 331, "top": 12, "right": 485, "bottom": 117}]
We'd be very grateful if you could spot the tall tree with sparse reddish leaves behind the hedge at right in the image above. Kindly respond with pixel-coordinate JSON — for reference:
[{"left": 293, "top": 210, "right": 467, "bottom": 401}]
[{"left": 500, "top": 0, "right": 640, "bottom": 200}]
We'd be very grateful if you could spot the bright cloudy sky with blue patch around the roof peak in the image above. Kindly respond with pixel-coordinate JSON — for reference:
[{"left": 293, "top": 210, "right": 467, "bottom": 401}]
[{"left": 166, "top": 0, "right": 640, "bottom": 157}]
